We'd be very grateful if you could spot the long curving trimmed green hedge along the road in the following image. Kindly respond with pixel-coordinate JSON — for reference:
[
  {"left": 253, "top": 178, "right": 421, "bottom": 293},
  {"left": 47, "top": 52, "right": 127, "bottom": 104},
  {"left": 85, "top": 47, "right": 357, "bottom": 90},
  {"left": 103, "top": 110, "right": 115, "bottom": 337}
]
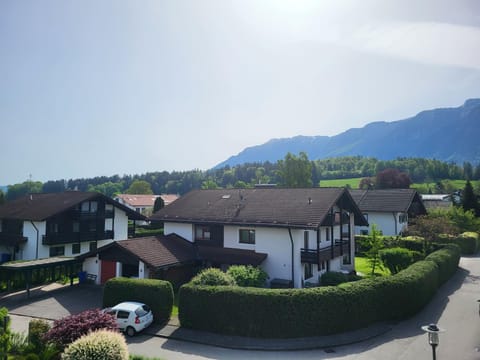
[{"left": 179, "top": 246, "right": 460, "bottom": 338}]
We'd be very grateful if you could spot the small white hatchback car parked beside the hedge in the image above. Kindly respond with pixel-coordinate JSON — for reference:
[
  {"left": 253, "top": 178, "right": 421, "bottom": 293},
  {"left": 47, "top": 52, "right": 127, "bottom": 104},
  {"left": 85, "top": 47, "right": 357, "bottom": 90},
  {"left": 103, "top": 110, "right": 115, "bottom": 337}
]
[{"left": 104, "top": 301, "right": 153, "bottom": 336}]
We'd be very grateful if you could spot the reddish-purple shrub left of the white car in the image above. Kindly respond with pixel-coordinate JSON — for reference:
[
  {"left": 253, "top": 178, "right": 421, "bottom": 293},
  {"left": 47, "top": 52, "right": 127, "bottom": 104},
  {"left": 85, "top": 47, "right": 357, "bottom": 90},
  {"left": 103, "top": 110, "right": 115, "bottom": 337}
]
[{"left": 45, "top": 309, "right": 118, "bottom": 349}]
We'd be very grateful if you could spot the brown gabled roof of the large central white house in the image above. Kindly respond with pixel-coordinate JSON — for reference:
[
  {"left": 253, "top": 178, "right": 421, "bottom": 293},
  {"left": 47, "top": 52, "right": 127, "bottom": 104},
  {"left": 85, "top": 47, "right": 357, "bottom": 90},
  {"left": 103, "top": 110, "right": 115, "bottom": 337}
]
[{"left": 150, "top": 188, "right": 368, "bottom": 229}]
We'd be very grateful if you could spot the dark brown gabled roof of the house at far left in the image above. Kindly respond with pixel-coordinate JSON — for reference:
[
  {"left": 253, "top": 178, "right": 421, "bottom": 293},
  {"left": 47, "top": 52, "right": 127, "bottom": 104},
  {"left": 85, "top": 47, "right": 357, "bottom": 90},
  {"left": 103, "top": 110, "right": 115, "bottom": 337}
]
[{"left": 0, "top": 191, "right": 145, "bottom": 221}]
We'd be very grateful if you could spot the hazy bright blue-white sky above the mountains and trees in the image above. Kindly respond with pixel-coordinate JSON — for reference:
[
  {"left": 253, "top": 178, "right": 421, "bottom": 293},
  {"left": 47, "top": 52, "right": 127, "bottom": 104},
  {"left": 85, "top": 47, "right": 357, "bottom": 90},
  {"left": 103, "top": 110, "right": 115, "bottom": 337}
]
[{"left": 0, "top": 0, "right": 480, "bottom": 185}]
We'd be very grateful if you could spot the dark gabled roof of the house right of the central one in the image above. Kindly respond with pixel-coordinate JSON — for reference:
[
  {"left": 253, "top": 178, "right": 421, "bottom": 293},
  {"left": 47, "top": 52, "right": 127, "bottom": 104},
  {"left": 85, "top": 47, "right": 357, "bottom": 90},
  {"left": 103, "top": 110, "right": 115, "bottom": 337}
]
[{"left": 350, "top": 189, "right": 427, "bottom": 214}]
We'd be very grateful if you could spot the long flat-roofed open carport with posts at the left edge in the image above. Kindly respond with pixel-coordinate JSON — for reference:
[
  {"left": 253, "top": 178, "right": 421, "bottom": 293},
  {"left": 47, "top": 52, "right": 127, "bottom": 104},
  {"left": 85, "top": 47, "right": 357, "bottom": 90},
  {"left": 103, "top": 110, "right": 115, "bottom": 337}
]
[{"left": 0, "top": 257, "right": 82, "bottom": 298}]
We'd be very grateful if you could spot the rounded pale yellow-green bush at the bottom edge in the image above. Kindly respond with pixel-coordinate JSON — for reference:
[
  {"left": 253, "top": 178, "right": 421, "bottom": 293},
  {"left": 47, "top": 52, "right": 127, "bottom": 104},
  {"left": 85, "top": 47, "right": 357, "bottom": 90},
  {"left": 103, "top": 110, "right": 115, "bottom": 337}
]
[{"left": 62, "top": 330, "right": 129, "bottom": 360}]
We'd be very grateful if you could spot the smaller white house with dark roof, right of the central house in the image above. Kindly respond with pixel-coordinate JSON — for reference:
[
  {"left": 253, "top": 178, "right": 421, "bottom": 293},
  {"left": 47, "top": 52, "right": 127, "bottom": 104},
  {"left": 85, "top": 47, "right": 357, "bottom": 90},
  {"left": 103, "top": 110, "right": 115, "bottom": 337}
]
[{"left": 350, "top": 189, "right": 427, "bottom": 235}]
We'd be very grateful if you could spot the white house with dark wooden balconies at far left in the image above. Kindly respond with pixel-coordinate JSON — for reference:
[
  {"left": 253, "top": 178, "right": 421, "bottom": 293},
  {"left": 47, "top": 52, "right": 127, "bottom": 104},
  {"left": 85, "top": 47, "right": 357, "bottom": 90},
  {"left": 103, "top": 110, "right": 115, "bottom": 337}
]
[{"left": 0, "top": 191, "right": 145, "bottom": 260}]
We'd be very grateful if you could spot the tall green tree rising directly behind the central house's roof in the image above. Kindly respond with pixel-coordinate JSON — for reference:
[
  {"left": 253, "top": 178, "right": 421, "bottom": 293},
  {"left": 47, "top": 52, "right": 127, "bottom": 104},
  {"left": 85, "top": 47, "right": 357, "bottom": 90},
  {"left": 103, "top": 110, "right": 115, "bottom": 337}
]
[{"left": 277, "top": 152, "right": 312, "bottom": 188}]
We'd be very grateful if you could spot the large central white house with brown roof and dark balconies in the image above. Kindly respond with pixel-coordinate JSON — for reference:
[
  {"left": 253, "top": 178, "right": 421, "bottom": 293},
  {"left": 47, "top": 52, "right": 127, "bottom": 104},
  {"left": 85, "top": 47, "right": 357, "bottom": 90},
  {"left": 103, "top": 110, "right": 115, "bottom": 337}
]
[{"left": 150, "top": 188, "right": 368, "bottom": 287}]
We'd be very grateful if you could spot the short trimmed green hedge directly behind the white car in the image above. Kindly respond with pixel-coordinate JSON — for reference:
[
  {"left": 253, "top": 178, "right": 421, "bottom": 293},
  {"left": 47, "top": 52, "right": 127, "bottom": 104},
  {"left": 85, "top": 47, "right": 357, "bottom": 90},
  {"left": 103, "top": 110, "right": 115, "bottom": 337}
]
[{"left": 103, "top": 277, "right": 173, "bottom": 323}]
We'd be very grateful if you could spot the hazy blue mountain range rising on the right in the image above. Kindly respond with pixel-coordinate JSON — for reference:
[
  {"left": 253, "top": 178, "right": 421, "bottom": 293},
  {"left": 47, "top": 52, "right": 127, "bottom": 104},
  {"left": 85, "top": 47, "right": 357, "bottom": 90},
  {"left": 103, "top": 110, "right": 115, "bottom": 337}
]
[{"left": 215, "top": 99, "right": 480, "bottom": 168}]
